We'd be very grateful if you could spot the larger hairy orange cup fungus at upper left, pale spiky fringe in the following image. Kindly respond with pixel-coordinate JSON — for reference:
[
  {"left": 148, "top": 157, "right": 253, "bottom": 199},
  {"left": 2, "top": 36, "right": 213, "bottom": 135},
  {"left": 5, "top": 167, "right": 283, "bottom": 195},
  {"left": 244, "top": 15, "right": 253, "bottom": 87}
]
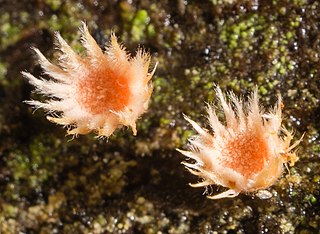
[{"left": 22, "top": 23, "right": 156, "bottom": 137}]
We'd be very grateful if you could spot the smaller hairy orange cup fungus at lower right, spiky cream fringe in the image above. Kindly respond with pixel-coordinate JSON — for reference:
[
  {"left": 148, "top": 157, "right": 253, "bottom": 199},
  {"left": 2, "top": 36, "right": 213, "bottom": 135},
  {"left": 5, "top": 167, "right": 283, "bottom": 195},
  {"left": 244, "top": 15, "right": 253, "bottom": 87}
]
[{"left": 178, "top": 87, "right": 300, "bottom": 199}]
